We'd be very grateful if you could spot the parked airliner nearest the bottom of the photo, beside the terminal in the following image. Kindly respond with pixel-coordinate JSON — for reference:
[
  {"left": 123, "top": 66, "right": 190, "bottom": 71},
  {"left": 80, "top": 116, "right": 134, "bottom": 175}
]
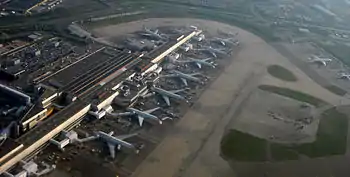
[{"left": 96, "top": 131, "right": 140, "bottom": 159}]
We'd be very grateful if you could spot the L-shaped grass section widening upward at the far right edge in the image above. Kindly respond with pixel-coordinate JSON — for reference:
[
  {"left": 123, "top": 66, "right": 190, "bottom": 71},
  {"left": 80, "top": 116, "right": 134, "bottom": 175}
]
[{"left": 293, "top": 108, "right": 348, "bottom": 157}]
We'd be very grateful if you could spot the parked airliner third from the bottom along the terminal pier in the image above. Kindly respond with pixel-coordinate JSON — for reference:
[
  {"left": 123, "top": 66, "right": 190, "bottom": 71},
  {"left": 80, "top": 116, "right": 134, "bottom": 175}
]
[{"left": 143, "top": 86, "right": 189, "bottom": 106}]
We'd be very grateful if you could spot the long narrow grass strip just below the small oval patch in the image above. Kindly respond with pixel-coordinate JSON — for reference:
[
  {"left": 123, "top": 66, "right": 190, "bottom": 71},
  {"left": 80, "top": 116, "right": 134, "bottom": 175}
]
[{"left": 259, "top": 85, "right": 326, "bottom": 107}]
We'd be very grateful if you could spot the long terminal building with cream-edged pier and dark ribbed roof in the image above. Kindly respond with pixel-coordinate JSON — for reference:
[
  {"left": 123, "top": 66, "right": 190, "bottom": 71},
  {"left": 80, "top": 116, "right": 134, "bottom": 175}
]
[{"left": 0, "top": 30, "right": 201, "bottom": 174}]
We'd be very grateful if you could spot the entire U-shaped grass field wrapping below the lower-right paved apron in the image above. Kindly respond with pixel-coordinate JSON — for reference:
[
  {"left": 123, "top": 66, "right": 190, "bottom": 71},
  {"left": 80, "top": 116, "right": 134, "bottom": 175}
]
[{"left": 221, "top": 108, "right": 348, "bottom": 162}]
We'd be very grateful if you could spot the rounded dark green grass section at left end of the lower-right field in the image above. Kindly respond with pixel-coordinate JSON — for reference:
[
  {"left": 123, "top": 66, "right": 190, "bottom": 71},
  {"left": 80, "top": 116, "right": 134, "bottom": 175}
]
[{"left": 221, "top": 130, "right": 266, "bottom": 161}]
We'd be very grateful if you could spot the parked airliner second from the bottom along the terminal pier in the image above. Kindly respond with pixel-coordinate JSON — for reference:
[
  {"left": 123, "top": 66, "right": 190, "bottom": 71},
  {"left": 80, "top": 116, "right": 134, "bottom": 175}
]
[{"left": 111, "top": 107, "right": 163, "bottom": 127}]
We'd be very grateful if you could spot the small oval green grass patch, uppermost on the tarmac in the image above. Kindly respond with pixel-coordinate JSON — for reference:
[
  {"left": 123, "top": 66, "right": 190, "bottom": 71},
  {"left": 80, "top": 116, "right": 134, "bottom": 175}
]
[{"left": 267, "top": 65, "right": 297, "bottom": 82}]
